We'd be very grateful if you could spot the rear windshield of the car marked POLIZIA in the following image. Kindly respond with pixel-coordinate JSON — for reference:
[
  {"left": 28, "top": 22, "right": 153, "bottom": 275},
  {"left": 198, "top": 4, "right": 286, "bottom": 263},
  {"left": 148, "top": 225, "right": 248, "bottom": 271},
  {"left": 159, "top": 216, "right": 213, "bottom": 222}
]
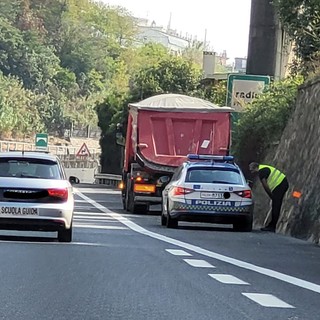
[{"left": 186, "top": 168, "right": 243, "bottom": 184}]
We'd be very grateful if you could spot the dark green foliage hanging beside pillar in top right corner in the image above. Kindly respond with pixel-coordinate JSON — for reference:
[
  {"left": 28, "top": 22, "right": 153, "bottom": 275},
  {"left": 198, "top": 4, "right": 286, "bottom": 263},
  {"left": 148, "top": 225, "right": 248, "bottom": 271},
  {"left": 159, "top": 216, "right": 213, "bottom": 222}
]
[{"left": 274, "top": 0, "right": 320, "bottom": 71}]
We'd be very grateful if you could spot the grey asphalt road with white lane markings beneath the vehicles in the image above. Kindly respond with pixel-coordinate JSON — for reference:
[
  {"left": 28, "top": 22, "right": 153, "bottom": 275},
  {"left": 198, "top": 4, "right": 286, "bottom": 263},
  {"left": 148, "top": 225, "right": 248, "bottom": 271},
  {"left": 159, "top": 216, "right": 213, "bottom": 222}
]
[{"left": 0, "top": 186, "right": 320, "bottom": 320}]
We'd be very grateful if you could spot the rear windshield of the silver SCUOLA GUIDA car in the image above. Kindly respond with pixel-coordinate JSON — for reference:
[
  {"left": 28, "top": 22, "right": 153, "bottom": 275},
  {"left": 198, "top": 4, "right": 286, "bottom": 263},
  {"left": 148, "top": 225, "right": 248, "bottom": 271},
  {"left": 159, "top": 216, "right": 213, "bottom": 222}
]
[{"left": 0, "top": 157, "right": 61, "bottom": 179}]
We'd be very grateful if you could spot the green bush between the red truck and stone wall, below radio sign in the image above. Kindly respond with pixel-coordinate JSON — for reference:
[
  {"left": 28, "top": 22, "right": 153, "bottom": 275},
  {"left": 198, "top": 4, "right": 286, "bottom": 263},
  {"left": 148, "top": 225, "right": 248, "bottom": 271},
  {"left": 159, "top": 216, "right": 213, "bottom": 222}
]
[{"left": 233, "top": 77, "right": 303, "bottom": 166}]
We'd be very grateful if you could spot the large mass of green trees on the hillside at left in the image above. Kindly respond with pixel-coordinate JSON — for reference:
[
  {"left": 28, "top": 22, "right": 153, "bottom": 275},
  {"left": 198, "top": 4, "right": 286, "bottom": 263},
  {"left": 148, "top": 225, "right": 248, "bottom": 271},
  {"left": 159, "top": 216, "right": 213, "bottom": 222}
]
[{"left": 0, "top": 0, "right": 136, "bottom": 135}]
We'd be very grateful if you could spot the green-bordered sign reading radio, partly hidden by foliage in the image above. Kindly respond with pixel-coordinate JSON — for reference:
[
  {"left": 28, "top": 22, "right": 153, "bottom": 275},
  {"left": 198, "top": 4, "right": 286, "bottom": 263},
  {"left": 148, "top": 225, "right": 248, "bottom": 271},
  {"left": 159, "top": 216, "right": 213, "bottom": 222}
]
[{"left": 227, "top": 74, "right": 270, "bottom": 111}]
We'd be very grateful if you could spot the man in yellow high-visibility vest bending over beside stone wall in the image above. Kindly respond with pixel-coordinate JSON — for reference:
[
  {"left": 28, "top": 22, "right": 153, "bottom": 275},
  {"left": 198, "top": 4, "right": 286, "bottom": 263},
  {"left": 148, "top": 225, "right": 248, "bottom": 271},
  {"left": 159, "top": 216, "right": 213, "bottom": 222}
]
[{"left": 249, "top": 162, "right": 289, "bottom": 232}]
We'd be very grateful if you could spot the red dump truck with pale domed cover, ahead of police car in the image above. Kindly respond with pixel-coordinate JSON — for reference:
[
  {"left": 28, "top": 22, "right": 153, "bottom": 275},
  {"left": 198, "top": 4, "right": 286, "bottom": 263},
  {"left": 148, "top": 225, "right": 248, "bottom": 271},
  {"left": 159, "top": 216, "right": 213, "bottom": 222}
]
[{"left": 121, "top": 94, "right": 233, "bottom": 214}]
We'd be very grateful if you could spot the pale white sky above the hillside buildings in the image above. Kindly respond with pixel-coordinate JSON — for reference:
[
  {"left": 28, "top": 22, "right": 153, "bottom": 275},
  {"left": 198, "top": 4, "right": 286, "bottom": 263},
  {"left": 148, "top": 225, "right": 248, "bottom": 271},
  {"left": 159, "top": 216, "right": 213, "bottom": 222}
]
[{"left": 100, "top": 0, "right": 251, "bottom": 59}]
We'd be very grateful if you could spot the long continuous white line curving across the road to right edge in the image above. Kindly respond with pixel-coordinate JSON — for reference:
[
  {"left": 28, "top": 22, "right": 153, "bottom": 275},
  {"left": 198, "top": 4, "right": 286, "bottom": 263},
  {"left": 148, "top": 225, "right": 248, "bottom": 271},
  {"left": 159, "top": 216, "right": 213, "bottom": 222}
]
[{"left": 78, "top": 192, "right": 320, "bottom": 293}]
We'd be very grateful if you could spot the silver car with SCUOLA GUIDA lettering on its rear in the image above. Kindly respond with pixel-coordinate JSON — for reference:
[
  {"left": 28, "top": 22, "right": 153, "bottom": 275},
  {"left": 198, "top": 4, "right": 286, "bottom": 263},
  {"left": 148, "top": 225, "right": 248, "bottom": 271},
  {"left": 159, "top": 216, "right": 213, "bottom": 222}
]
[{"left": 0, "top": 151, "right": 79, "bottom": 242}]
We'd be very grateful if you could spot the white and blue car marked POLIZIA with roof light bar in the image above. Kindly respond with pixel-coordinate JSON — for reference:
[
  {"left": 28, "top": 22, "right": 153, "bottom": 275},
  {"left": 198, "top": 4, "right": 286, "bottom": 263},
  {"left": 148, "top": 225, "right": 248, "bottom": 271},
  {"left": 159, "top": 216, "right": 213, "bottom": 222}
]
[{"left": 161, "top": 155, "right": 253, "bottom": 231}]
